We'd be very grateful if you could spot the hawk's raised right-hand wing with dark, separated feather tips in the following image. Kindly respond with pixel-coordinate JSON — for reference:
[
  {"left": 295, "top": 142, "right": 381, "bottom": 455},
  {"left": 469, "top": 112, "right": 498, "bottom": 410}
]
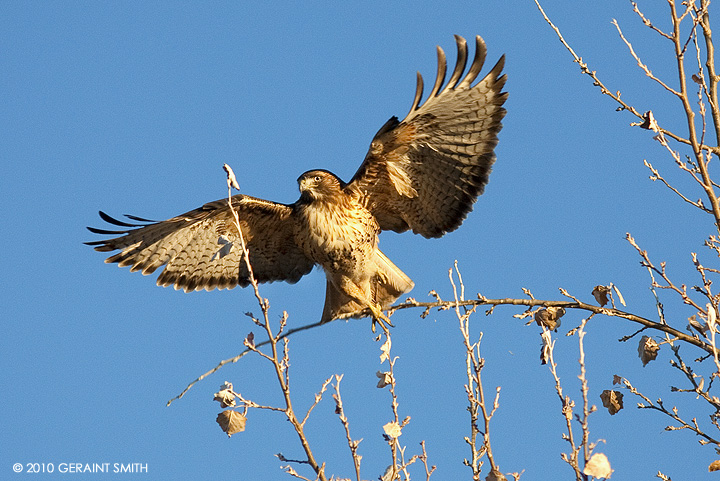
[{"left": 345, "top": 35, "right": 507, "bottom": 237}]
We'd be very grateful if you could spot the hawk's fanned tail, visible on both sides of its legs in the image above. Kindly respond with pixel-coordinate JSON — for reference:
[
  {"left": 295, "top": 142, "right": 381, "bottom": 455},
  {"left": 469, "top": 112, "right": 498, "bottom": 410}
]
[{"left": 321, "top": 250, "right": 415, "bottom": 322}]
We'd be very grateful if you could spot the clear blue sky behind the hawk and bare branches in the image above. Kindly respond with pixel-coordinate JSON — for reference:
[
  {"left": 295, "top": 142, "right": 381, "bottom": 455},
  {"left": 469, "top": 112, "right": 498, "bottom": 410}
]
[{"left": 0, "top": 0, "right": 714, "bottom": 480}]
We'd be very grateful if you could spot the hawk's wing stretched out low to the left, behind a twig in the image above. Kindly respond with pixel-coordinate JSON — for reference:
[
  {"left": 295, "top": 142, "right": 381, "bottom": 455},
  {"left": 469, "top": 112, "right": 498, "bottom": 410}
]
[{"left": 87, "top": 195, "right": 313, "bottom": 292}]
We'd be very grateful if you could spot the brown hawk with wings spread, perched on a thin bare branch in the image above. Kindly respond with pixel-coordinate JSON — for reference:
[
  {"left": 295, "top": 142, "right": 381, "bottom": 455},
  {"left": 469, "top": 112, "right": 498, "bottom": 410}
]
[{"left": 87, "top": 36, "right": 507, "bottom": 328}]
